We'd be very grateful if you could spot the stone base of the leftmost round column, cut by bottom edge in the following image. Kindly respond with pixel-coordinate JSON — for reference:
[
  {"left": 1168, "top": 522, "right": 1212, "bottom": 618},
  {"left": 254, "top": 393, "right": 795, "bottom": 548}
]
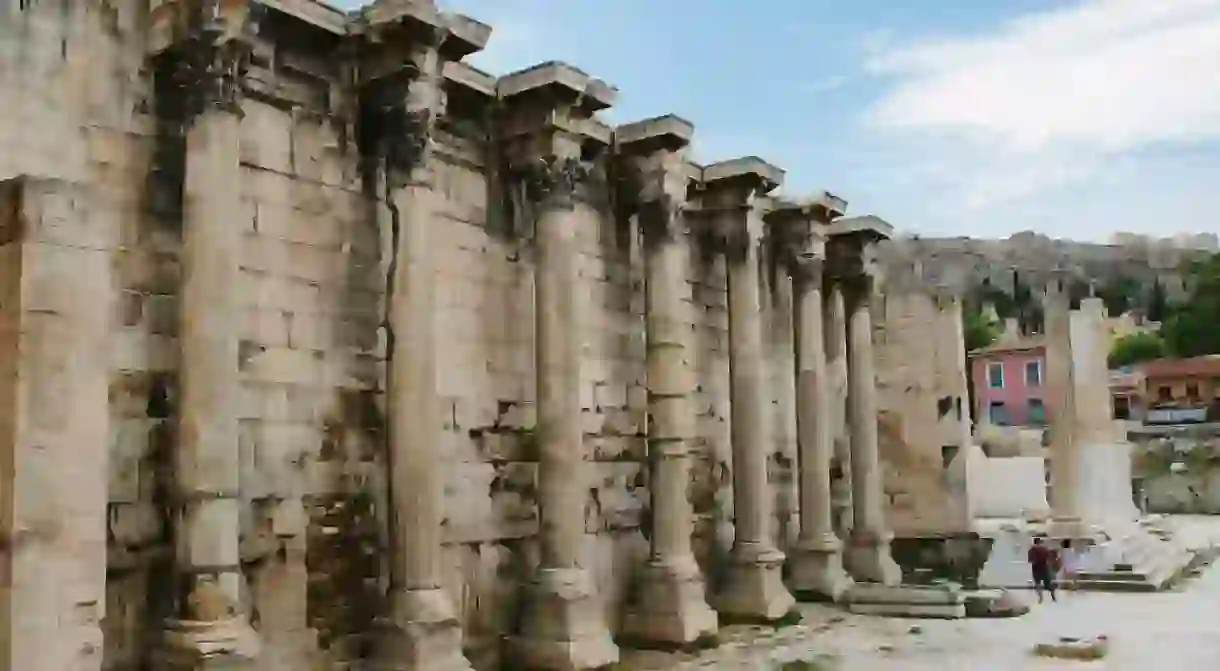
[{"left": 154, "top": 616, "right": 262, "bottom": 671}]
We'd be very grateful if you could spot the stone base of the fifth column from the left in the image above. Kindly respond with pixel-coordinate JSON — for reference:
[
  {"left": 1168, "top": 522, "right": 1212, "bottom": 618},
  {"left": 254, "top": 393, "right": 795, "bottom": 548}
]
[{"left": 716, "top": 543, "right": 797, "bottom": 622}]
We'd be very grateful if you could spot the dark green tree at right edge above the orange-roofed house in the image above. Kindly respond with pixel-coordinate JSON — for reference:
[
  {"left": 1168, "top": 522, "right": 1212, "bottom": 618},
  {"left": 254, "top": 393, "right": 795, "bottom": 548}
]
[{"left": 1161, "top": 254, "right": 1220, "bottom": 357}]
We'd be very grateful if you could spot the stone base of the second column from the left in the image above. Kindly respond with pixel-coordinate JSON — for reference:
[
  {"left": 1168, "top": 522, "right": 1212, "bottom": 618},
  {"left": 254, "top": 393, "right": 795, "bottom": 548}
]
[{"left": 367, "top": 588, "right": 471, "bottom": 671}]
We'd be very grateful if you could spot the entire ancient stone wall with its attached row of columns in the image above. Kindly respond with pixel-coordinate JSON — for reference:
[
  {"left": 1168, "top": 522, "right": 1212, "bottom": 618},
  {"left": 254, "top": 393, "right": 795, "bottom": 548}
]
[{"left": 0, "top": 0, "right": 961, "bottom": 671}]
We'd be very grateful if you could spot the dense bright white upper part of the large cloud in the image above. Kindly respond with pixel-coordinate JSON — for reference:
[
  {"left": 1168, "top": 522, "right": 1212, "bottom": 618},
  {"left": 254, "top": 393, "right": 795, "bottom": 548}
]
[{"left": 870, "top": 0, "right": 1220, "bottom": 150}]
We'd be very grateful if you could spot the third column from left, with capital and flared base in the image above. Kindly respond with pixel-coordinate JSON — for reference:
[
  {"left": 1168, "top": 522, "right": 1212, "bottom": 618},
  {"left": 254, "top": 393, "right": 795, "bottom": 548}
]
[{"left": 497, "top": 62, "right": 619, "bottom": 670}]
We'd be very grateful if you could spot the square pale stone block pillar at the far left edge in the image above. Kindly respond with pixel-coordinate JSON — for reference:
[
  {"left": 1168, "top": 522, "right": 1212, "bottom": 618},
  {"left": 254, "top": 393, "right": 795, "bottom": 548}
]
[{"left": 0, "top": 178, "right": 118, "bottom": 671}]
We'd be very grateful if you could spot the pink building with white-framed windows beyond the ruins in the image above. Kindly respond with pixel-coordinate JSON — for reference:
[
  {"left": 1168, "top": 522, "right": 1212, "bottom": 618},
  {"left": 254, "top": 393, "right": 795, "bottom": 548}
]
[{"left": 970, "top": 336, "right": 1047, "bottom": 426}]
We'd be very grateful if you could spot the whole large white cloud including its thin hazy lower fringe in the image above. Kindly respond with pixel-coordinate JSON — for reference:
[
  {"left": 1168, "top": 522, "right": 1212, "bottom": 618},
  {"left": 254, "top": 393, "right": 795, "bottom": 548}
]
[{"left": 865, "top": 0, "right": 1220, "bottom": 238}]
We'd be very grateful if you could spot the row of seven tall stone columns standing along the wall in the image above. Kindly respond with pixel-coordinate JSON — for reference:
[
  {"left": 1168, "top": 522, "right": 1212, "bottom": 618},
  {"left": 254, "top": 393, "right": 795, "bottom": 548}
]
[{"left": 150, "top": 15, "right": 895, "bottom": 670}]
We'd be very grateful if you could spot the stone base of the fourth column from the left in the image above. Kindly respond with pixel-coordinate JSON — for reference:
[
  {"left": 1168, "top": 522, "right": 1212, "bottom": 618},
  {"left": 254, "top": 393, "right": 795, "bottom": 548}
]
[{"left": 623, "top": 558, "right": 720, "bottom": 647}]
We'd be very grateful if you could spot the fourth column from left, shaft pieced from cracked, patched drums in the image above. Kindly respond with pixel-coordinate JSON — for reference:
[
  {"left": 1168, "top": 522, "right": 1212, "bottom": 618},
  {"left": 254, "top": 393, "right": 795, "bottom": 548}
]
[{"left": 615, "top": 116, "right": 719, "bottom": 645}]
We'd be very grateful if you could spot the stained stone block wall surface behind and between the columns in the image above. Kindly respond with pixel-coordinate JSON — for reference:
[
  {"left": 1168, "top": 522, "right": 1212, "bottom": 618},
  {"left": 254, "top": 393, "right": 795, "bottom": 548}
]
[{"left": 0, "top": 2, "right": 794, "bottom": 671}]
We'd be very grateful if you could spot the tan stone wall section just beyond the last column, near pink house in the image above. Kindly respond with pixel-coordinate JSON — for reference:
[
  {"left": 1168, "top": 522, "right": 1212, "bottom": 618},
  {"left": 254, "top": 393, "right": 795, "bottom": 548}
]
[{"left": 875, "top": 289, "right": 971, "bottom": 537}]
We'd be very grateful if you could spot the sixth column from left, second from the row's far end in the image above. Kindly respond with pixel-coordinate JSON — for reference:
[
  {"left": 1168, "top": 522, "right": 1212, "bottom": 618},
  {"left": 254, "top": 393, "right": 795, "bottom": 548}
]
[{"left": 769, "top": 194, "right": 852, "bottom": 601}]
